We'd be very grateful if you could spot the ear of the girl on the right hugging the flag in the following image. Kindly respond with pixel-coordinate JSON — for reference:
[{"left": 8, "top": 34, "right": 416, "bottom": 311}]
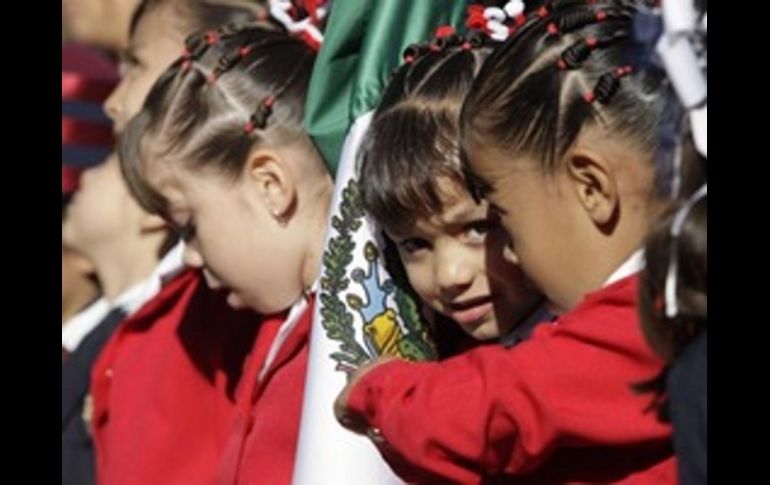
[{"left": 566, "top": 150, "right": 620, "bottom": 232}]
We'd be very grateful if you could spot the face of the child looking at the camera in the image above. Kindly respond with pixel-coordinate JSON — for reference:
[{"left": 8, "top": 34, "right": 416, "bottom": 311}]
[{"left": 389, "top": 178, "right": 540, "bottom": 340}]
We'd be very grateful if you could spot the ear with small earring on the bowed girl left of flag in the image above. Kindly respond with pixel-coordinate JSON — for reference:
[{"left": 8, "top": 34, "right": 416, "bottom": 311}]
[{"left": 243, "top": 149, "right": 297, "bottom": 223}]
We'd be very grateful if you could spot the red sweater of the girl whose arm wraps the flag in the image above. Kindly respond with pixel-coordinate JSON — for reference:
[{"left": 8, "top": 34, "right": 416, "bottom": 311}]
[{"left": 348, "top": 276, "right": 676, "bottom": 484}]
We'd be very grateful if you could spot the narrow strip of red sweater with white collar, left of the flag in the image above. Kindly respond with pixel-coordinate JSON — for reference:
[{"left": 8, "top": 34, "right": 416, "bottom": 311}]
[{"left": 219, "top": 299, "right": 313, "bottom": 485}]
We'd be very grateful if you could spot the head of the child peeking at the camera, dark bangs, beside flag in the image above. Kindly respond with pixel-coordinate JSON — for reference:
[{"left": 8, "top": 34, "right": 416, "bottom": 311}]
[{"left": 359, "top": 34, "right": 545, "bottom": 354}]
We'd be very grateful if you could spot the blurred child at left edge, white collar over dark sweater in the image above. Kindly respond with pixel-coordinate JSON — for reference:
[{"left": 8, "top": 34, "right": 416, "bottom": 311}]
[{"left": 62, "top": 155, "right": 181, "bottom": 484}]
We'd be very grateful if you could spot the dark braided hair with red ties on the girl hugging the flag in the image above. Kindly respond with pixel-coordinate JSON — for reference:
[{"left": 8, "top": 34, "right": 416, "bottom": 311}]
[{"left": 461, "top": 0, "right": 666, "bottom": 189}]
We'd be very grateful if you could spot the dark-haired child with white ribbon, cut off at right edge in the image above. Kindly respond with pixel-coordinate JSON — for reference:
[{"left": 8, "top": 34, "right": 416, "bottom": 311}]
[{"left": 638, "top": 185, "right": 708, "bottom": 484}]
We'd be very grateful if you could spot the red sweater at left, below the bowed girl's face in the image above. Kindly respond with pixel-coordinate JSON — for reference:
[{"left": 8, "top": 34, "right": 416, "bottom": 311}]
[{"left": 91, "top": 270, "right": 259, "bottom": 485}]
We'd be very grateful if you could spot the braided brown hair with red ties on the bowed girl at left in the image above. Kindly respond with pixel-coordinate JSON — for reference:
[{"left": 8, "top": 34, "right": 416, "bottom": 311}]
[{"left": 120, "top": 25, "right": 315, "bottom": 214}]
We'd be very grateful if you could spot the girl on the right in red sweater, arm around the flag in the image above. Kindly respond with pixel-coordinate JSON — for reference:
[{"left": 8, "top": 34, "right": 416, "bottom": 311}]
[{"left": 339, "top": 1, "right": 675, "bottom": 483}]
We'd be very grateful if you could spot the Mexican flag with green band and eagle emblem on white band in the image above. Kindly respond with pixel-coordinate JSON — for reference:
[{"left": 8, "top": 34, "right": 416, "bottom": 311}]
[{"left": 294, "top": 0, "right": 467, "bottom": 485}]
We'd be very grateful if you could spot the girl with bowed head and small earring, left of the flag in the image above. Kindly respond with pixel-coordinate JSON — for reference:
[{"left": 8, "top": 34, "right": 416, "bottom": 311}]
[{"left": 121, "top": 28, "right": 333, "bottom": 483}]
